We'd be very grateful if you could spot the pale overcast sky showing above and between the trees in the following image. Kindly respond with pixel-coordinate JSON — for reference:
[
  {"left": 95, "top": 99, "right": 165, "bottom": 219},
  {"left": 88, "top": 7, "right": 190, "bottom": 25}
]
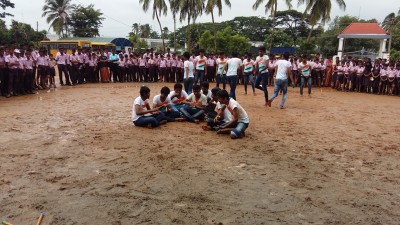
[{"left": 6, "top": 0, "right": 400, "bottom": 37}]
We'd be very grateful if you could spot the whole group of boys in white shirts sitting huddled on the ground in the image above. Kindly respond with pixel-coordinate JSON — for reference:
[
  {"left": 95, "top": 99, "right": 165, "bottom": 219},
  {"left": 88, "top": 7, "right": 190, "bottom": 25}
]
[{"left": 132, "top": 82, "right": 250, "bottom": 139}]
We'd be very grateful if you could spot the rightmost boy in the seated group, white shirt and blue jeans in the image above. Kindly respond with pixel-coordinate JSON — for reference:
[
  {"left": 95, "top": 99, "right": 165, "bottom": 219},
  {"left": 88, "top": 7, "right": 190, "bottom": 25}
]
[{"left": 217, "top": 90, "right": 250, "bottom": 139}]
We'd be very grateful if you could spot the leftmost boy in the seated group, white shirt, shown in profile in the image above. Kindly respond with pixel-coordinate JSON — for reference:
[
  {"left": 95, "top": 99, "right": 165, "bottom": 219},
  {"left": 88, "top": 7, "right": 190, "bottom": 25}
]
[{"left": 132, "top": 86, "right": 168, "bottom": 128}]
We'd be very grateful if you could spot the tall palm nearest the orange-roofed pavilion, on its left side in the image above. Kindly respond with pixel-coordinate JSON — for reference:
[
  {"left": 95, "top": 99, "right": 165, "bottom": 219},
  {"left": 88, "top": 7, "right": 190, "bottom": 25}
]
[{"left": 299, "top": 0, "right": 346, "bottom": 41}]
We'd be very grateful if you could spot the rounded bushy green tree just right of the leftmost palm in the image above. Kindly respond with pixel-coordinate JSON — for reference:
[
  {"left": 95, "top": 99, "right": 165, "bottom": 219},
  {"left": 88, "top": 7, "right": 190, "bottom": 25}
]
[{"left": 69, "top": 4, "right": 104, "bottom": 37}]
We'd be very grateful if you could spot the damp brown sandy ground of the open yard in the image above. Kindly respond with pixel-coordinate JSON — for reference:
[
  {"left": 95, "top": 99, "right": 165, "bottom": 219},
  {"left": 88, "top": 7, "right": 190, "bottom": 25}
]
[{"left": 0, "top": 81, "right": 400, "bottom": 225}]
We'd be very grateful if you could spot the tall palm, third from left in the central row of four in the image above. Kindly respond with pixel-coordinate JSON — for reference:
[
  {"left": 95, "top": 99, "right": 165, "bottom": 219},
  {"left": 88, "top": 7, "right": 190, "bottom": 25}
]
[{"left": 179, "top": 0, "right": 204, "bottom": 52}]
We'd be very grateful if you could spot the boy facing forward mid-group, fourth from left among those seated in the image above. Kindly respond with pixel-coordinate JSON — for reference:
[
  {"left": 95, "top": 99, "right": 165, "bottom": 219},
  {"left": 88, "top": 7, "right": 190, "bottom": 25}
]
[{"left": 180, "top": 84, "right": 207, "bottom": 123}]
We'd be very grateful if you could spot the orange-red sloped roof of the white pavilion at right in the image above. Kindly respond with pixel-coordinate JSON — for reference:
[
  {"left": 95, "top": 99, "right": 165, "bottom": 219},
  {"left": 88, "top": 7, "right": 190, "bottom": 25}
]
[{"left": 338, "top": 23, "right": 391, "bottom": 39}]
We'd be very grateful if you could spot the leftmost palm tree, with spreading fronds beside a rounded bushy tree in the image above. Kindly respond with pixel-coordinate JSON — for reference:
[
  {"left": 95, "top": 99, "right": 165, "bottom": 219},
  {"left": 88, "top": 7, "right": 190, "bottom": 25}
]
[{"left": 42, "top": 0, "right": 74, "bottom": 37}]
